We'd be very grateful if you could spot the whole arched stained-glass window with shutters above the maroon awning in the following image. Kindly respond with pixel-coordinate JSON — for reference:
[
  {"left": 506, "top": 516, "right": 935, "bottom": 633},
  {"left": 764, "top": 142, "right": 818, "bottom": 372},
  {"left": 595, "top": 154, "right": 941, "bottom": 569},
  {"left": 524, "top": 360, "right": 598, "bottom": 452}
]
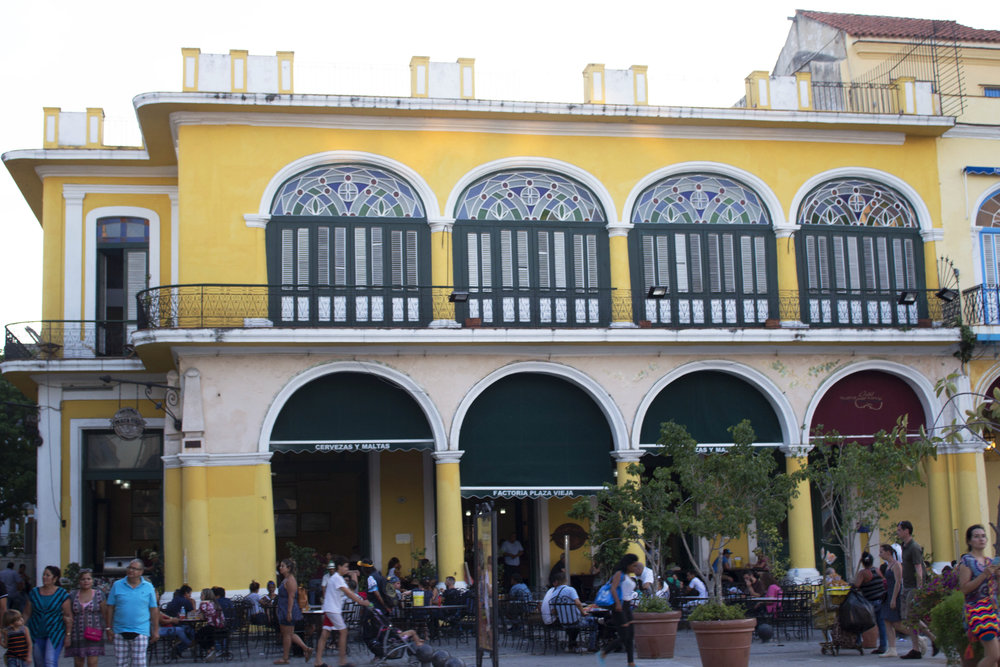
[{"left": 796, "top": 178, "right": 927, "bottom": 326}]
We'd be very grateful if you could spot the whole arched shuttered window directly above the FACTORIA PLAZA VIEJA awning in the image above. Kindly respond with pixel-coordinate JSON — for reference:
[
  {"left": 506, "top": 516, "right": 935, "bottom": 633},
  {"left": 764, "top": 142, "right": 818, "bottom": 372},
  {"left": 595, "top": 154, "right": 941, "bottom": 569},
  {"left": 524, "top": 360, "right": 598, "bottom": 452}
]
[{"left": 454, "top": 170, "right": 611, "bottom": 327}]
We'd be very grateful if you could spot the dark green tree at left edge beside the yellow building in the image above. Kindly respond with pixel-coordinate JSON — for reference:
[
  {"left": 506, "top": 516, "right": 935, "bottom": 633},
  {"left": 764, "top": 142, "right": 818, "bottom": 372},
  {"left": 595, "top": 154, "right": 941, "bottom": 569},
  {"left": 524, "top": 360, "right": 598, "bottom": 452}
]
[{"left": 0, "top": 370, "right": 41, "bottom": 522}]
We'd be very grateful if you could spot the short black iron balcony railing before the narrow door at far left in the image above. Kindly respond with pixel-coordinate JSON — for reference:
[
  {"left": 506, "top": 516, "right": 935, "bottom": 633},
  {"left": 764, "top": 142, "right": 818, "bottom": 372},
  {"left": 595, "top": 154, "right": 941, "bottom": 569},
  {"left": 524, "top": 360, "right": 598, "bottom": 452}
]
[{"left": 4, "top": 320, "right": 136, "bottom": 361}]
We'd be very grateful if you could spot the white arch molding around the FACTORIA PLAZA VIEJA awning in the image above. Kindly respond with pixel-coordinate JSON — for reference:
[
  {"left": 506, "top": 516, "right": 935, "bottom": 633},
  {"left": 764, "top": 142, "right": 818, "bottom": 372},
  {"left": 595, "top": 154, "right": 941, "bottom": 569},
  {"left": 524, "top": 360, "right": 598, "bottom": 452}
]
[{"left": 448, "top": 361, "right": 628, "bottom": 454}]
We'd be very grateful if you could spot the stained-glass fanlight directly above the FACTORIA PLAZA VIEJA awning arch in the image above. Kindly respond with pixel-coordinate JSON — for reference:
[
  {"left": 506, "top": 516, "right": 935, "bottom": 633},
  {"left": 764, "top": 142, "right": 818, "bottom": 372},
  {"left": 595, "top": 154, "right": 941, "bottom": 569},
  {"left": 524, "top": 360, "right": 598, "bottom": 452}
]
[{"left": 455, "top": 171, "right": 605, "bottom": 222}]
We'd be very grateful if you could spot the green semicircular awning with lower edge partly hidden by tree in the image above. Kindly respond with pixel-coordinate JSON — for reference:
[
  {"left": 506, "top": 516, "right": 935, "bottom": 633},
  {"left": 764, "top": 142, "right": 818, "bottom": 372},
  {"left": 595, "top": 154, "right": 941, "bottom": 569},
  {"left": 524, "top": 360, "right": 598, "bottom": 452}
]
[{"left": 639, "top": 371, "right": 782, "bottom": 451}]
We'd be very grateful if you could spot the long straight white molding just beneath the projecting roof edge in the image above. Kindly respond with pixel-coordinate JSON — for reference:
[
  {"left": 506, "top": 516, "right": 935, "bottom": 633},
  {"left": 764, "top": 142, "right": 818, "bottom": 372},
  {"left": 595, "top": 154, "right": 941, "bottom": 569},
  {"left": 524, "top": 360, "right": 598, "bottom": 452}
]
[{"left": 170, "top": 109, "right": 906, "bottom": 146}]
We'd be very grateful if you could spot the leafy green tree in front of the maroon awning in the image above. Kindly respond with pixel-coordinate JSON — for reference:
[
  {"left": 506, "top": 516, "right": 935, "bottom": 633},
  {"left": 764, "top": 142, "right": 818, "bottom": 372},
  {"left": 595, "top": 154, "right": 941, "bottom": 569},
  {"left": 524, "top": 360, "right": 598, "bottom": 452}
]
[{"left": 806, "top": 422, "right": 936, "bottom": 579}]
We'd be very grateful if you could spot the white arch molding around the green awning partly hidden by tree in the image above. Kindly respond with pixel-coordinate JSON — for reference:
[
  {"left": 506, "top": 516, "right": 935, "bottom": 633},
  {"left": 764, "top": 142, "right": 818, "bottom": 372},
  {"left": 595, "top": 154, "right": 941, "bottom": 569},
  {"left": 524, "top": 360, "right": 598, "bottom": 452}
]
[{"left": 632, "top": 359, "right": 800, "bottom": 451}]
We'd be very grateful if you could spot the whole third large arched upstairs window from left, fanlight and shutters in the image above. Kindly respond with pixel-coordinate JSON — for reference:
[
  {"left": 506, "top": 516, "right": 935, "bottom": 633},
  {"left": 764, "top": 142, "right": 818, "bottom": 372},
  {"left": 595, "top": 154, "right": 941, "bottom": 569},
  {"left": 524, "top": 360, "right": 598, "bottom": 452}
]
[{"left": 629, "top": 174, "right": 778, "bottom": 326}]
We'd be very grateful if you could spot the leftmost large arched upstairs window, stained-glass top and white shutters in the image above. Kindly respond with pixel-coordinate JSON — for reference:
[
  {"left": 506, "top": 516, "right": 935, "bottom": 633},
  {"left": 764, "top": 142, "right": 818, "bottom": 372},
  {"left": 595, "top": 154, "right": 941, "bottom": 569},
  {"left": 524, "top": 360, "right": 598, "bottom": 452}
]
[{"left": 267, "top": 165, "right": 431, "bottom": 326}]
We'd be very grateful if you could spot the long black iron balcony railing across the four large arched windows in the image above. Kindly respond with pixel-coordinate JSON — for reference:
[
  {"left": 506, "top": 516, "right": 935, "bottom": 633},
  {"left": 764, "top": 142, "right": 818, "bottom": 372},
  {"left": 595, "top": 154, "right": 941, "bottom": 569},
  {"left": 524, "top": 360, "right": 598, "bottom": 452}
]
[{"left": 117, "top": 284, "right": 960, "bottom": 332}]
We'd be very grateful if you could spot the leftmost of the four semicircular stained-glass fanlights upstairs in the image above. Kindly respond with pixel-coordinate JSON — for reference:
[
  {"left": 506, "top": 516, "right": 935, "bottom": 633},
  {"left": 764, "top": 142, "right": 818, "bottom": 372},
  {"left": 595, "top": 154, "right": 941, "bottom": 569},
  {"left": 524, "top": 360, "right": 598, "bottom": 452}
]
[{"left": 271, "top": 165, "right": 425, "bottom": 218}]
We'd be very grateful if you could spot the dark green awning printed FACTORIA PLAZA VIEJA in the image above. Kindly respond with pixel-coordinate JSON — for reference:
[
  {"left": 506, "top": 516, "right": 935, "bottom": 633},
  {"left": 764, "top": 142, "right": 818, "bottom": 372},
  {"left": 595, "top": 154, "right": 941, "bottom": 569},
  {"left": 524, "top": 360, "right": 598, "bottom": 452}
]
[{"left": 459, "top": 373, "right": 614, "bottom": 498}]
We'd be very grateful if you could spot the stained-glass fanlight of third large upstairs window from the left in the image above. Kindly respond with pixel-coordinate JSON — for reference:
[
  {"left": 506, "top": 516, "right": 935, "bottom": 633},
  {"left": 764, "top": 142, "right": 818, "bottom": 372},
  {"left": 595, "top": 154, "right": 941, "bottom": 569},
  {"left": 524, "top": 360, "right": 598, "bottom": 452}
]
[{"left": 632, "top": 174, "right": 771, "bottom": 225}]
